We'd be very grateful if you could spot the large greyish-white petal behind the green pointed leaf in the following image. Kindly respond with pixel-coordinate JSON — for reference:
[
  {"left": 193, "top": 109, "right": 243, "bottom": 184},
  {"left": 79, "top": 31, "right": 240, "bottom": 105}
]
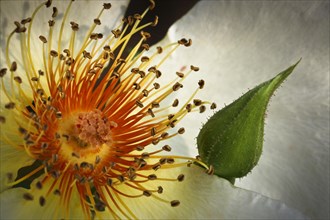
[{"left": 168, "top": 1, "right": 329, "bottom": 218}]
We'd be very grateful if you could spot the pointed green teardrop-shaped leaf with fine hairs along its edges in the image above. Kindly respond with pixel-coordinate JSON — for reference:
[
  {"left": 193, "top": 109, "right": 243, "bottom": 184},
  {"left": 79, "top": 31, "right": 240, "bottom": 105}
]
[{"left": 197, "top": 60, "right": 300, "bottom": 181}]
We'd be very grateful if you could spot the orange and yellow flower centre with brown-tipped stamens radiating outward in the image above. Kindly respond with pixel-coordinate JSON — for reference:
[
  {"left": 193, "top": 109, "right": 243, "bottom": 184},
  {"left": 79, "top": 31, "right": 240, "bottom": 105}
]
[{"left": 0, "top": 1, "right": 215, "bottom": 218}]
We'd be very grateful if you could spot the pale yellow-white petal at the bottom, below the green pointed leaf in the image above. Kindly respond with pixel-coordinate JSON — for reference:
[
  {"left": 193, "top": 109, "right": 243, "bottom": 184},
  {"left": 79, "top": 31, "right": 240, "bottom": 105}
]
[{"left": 98, "top": 166, "right": 304, "bottom": 219}]
